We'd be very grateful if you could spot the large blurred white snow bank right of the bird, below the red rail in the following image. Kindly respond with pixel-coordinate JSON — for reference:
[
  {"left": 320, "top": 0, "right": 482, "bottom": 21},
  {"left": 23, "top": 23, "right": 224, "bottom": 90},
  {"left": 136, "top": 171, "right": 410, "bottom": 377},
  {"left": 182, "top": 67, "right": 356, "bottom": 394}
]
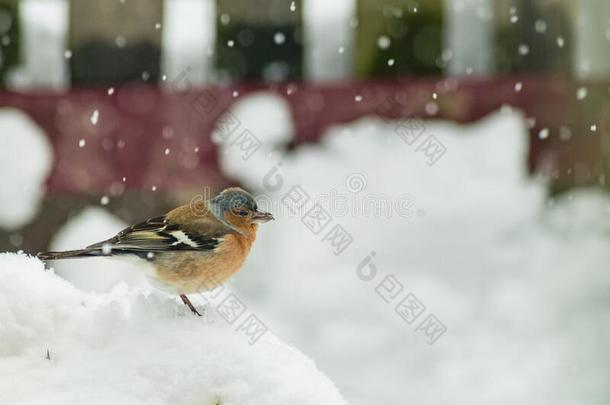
[{"left": 216, "top": 95, "right": 610, "bottom": 405}]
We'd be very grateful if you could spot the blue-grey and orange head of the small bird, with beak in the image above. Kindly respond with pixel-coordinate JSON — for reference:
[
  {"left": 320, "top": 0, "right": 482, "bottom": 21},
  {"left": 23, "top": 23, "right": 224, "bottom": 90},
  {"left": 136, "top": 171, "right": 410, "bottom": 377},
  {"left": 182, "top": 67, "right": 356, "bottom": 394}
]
[{"left": 209, "top": 187, "right": 274, "bottom": 233}]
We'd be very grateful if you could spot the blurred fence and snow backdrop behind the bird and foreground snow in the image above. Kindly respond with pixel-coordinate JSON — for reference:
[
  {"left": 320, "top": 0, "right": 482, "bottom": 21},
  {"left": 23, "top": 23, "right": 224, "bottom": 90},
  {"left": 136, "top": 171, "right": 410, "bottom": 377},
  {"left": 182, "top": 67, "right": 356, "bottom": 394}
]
[{"left": 0, "top": 0, "right": 610, "bottom": 404}]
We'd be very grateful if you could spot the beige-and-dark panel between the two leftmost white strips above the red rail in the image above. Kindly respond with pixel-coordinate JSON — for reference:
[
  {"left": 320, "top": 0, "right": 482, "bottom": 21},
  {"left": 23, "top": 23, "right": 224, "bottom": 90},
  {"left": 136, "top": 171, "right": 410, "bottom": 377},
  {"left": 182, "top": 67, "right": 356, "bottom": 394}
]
[{"left": 69, "top": 0, "right": 163, "bottom": 85}]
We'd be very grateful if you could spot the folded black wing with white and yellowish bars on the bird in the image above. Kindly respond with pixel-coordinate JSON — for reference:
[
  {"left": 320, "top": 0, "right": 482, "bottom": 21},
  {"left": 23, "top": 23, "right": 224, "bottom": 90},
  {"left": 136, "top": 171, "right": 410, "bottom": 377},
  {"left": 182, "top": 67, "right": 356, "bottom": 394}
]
[{"left": 87, "top": 216, "right": 220, "bottom": 252}]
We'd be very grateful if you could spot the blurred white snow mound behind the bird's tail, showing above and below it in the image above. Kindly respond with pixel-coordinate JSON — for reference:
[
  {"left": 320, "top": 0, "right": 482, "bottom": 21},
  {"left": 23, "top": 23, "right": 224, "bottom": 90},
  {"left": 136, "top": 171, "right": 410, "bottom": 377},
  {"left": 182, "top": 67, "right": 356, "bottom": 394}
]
[{"left": 50, "top": 207, "right": 147, "bottom": 292}]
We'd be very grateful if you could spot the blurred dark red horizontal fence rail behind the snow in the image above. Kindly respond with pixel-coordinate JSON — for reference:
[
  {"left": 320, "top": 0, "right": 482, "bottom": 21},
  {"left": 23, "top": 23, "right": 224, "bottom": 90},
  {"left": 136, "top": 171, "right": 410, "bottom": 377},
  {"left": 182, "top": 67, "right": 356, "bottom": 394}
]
[{"left": 0, "top": 77, "right": 610, "bottom": 193}]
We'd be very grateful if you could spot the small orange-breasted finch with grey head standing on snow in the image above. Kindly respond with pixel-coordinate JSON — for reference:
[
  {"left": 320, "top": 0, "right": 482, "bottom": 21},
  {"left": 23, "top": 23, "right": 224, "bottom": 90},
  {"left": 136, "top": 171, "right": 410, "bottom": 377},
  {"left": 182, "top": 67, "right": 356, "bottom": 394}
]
[{"left": 37, "top": 187, "right": 274, "bottom": 316}]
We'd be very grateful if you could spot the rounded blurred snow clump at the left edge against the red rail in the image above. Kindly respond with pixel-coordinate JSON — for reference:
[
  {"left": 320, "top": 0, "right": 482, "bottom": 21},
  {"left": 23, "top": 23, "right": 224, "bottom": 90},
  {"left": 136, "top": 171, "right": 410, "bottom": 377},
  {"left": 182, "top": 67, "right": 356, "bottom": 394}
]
[{"left": 0, "top": 108, "right": 53, "bottom": 230}]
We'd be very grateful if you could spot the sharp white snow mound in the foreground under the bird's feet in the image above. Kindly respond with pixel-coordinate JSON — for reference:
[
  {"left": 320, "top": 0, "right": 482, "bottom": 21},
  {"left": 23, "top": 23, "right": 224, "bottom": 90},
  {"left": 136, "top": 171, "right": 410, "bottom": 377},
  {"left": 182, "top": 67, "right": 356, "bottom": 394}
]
[{"left": 0, "top": 254, "right": 345, "bottom": 405}]
